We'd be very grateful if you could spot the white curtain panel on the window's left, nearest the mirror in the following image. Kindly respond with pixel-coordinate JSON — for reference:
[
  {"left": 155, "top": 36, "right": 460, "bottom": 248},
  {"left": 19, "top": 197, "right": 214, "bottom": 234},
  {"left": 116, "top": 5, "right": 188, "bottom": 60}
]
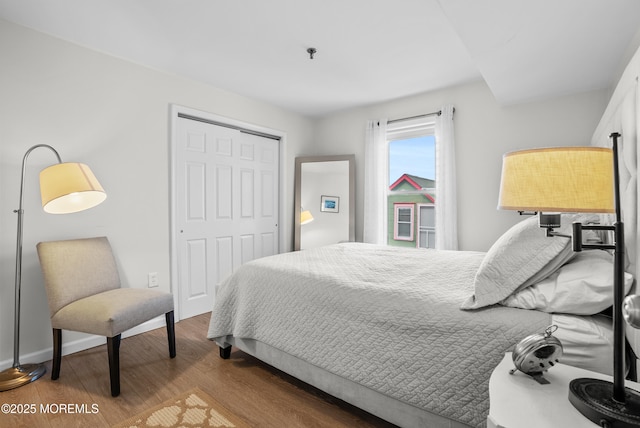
[{"left": 363, "top": 119, "right": 388, "bottom": 245}]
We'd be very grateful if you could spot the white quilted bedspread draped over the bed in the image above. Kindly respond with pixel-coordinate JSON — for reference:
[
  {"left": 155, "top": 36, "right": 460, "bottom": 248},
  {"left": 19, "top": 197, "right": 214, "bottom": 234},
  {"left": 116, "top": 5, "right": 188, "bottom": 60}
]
[{"left": 208, "top": 243, "right": 551, "bottom": 426}]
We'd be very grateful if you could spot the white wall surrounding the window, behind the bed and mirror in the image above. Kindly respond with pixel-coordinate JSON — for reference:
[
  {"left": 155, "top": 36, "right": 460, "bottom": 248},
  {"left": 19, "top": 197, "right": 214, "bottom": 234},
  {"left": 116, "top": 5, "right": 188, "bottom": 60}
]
[{"left": 316, "top": 82, "right": 608, "bottom": 251}]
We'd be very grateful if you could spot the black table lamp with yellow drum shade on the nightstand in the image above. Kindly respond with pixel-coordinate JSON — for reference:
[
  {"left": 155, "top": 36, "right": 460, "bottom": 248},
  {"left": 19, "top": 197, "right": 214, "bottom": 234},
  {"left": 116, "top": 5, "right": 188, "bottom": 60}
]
[{"left": 498, "top": 133, "right": 640, "bottom": 428}]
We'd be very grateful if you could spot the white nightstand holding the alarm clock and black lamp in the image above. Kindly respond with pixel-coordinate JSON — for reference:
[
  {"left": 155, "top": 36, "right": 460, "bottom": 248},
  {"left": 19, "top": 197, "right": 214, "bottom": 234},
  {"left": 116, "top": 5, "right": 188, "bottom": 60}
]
[{"left": 487, "top": 352, "right": 640, "bottom": 428}]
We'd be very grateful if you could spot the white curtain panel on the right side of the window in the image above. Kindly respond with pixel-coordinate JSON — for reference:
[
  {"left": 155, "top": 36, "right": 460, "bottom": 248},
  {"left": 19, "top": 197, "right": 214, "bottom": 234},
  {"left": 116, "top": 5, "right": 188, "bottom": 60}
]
[{"left": 435, "top": 104, "right": 458, "bottom": 250}]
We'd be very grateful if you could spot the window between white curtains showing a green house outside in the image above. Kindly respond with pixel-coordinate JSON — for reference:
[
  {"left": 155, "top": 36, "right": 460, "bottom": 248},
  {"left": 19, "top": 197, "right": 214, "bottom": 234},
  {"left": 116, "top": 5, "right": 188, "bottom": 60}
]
[{"left": 386, "top": 117, "right": 436, "bottom": 248}]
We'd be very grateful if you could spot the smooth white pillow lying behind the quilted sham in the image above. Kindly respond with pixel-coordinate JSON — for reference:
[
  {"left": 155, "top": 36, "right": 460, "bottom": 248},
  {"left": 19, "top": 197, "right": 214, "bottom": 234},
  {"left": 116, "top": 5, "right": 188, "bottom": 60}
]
[{"left": 500, "top": 250, "right": 633, "bottom": 315}]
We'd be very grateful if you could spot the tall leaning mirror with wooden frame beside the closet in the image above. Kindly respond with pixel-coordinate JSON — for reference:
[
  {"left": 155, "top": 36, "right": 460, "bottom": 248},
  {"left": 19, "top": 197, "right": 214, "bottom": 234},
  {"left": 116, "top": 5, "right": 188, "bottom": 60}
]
[{"left": 293, "top": 155, "right": 355, "bottom": 251}]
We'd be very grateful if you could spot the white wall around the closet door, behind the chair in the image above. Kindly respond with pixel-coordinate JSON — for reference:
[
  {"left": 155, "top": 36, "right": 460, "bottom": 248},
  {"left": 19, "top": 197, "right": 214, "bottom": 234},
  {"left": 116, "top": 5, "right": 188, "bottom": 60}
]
[{"left": 0, "top": 20, "right": 313, "bottom": 369}]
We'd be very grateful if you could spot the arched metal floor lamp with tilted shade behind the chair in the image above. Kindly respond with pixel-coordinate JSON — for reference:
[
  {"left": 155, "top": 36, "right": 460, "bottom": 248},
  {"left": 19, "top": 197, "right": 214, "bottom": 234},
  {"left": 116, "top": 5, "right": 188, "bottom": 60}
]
[{"left": 0, "top": 144, "right": 107, "bottom": 391}]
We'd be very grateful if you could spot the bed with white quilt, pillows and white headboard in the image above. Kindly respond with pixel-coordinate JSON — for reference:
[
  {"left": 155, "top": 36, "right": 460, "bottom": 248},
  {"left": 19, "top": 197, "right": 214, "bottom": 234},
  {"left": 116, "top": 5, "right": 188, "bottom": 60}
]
[{"left": 208, "top": 46, "right": 640, "bottom": 427}]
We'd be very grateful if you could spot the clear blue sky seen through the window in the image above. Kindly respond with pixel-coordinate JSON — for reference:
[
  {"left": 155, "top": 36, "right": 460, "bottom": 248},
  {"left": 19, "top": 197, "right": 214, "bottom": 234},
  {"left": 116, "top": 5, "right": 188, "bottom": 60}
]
[{"left": 389, "top": 135, "right": 436, "bottom": 184}]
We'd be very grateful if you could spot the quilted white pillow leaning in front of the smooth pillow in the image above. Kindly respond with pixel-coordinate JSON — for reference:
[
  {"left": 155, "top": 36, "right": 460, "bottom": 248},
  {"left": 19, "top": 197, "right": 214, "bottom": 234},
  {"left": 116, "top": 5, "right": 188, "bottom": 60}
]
[{"left": 461, "top": 214, "right": 598, "bottom": 309}]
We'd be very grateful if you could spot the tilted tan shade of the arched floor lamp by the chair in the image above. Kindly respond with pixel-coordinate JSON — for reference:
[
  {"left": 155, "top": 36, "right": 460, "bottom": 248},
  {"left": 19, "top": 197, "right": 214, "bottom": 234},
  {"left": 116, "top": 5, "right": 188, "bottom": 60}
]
[{"left": 40, "top": 162, "right": 107, "bottom": 214}]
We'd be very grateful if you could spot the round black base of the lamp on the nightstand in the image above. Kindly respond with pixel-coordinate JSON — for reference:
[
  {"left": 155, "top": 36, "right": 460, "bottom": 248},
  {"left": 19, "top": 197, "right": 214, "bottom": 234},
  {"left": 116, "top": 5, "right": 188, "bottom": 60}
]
[{"left": 569, "top": 378, "right": 640, "bottom": 428}]
